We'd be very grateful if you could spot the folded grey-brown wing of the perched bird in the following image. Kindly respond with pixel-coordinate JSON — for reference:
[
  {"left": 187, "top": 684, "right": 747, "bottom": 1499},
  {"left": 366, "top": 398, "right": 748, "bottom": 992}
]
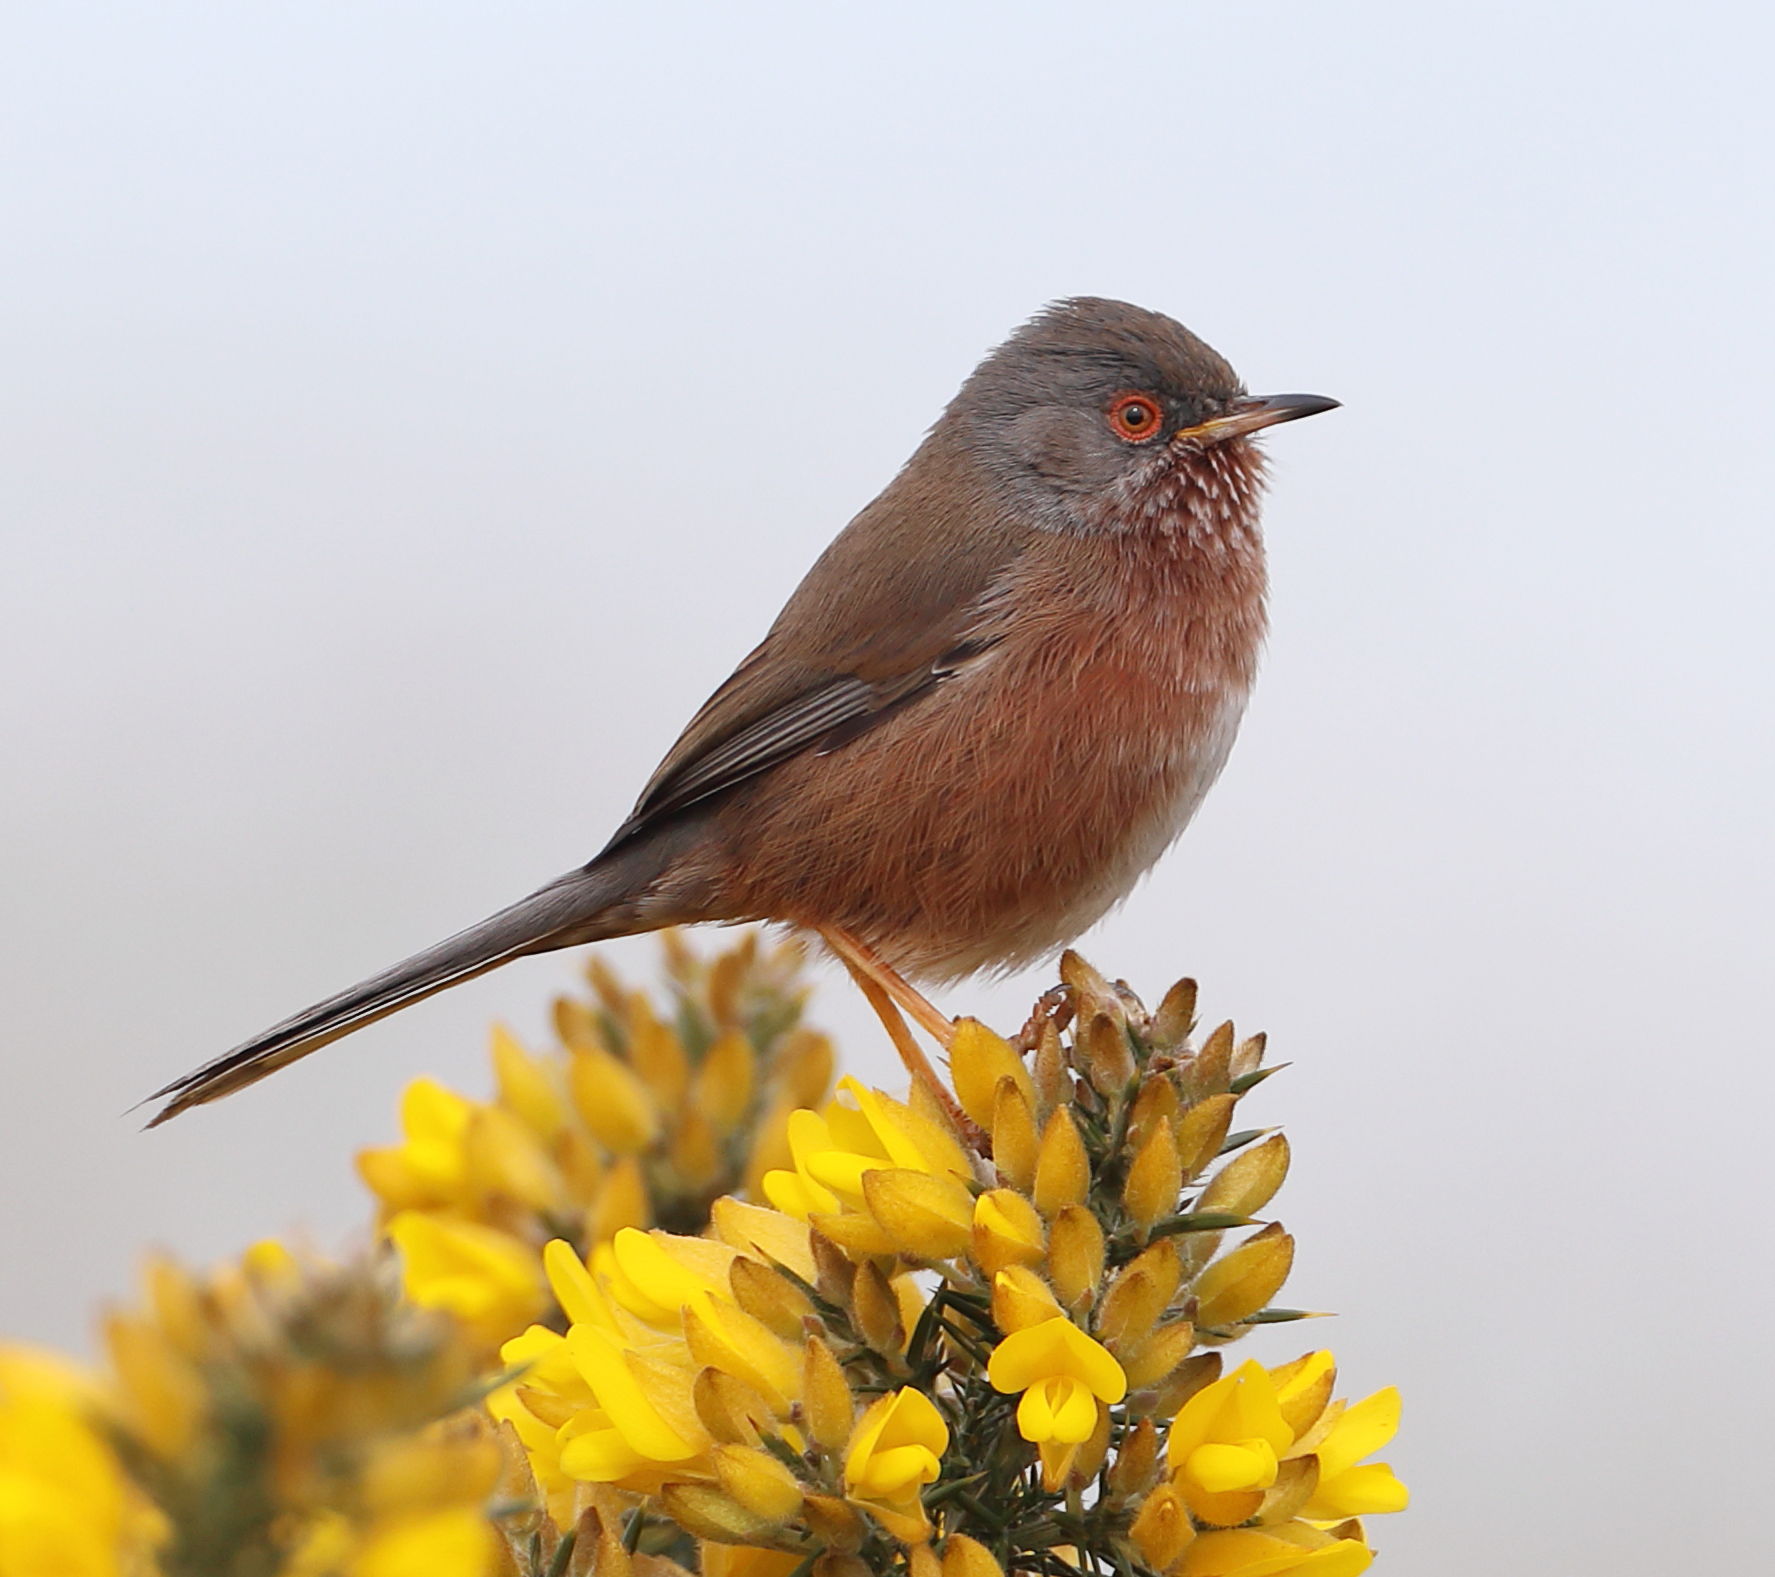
[{"left": 609, "top": 431, "right": 1030, "bottom": 849}]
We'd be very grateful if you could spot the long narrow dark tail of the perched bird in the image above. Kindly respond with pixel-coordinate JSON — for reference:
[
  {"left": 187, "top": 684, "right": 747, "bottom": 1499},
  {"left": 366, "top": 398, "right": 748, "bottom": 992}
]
[{"left": 147, "top": 860, "right": 656, "bottom": 1128}]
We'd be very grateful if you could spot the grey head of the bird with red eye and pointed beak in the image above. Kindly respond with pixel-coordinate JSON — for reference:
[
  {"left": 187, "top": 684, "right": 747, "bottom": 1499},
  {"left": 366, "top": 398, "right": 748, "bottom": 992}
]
[{"left": 944, "top": 297, "right": 1337, "bottom": 531}]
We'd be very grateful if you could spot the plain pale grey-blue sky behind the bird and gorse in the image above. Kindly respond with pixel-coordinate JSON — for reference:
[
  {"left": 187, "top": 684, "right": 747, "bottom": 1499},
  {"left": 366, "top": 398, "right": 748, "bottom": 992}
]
[{"left": 0, "top": 0, "right": 1775, "bottom": 1577}]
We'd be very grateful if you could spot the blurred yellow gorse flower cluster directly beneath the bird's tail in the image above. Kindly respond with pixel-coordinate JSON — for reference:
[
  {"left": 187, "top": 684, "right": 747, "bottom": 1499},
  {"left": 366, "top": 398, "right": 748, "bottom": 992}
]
[{"left": 359, "top": 938, "right": 831, "bottom": 1346}]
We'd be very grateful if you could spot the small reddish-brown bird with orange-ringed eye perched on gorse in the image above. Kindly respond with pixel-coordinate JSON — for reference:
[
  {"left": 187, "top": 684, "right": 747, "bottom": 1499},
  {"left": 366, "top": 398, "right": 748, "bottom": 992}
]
[{"left": 149, "top": 297, "right": 1338, "bottom": 1126}]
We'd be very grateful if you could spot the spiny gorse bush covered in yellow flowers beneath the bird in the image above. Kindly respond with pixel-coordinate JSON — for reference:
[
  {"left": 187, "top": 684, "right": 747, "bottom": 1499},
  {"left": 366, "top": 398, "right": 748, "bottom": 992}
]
[{"left": 0, "top": 938, "right": 1406, "bottom": 1577}]
